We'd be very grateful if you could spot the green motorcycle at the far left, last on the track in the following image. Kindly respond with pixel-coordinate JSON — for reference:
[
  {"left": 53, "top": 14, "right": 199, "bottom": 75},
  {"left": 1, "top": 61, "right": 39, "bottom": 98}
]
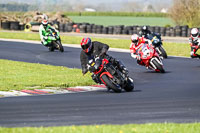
[{"left": 47, "top": 31, "right": 64, "bottom": 52}]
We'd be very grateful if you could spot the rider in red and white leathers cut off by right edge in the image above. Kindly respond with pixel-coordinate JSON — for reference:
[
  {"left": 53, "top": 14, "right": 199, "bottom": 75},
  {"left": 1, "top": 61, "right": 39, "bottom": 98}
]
[{"left": 189, "top": 28, "right": 200, "bottom": 58}]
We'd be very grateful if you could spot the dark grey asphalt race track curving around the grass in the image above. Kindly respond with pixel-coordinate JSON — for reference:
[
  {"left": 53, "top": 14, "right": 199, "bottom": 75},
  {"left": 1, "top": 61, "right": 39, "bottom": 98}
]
[{"left": 0, "top": 41, "right": 200, "bottom": 127}]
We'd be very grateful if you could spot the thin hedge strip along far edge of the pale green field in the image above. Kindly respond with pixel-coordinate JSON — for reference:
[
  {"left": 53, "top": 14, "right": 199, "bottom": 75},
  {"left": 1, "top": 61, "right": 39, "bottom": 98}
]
[{"left": 64, "top": 12, "right": 168, "bottom": 17}]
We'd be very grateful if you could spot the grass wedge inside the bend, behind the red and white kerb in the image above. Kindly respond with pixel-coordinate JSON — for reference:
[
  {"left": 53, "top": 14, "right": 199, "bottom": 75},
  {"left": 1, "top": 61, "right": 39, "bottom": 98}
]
[{"left": 0, "top": 60, "right": 95, "bottom": 91}]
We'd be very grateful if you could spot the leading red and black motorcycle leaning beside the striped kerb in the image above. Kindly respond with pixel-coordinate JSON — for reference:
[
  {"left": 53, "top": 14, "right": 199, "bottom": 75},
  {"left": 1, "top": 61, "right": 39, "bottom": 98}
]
[{"left": 88, "top": 57, "right": 134, "bottom": 93}]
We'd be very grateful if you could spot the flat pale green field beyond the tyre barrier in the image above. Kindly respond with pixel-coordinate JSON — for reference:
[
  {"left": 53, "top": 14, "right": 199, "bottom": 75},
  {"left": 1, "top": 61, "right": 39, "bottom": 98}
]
[{"left": 69, "top": 16, "right": 175, "bottom": 26}]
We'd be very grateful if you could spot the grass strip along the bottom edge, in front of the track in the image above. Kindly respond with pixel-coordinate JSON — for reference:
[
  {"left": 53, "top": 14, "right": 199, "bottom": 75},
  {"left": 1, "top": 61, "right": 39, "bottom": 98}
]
[{"left": 0, "top": 123, "right": 200, "bottom": 133}]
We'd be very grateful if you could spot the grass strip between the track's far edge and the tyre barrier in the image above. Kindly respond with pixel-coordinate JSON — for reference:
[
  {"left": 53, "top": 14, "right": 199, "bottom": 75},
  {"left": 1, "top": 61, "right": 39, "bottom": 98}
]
[{"left": 0, "top": 31, "right": 190, "bottom": 57}]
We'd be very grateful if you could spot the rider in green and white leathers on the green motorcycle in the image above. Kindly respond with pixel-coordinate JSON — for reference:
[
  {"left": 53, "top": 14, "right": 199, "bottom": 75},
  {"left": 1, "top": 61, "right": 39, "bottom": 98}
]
[{"left": 39, "top": 20, "right": 58, "bottom": 47}]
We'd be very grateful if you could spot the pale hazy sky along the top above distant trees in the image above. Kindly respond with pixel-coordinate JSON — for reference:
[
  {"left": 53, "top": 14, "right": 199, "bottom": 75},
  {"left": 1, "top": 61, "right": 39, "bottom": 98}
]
[{"left": 0, "top": 0, "right": 173, "bottom": 11}]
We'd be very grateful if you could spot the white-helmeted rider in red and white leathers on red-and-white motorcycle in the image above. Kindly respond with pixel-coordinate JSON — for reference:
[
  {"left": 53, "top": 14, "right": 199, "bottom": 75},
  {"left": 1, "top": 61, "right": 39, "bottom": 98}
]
[{"left": 130, "top": 34, "right": 152, "bottom": 66}]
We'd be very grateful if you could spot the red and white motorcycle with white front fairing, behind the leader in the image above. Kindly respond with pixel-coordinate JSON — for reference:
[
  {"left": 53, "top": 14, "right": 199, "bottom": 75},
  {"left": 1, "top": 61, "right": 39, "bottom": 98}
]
[{"left": 136, "top": 43, "right": 165, "bottom": 73}]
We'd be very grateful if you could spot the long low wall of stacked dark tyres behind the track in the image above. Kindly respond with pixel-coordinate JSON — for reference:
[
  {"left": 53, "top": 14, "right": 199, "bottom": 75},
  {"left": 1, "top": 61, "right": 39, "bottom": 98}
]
[{"left": 1, "top": 22, "right": 191, "bottom": 37}]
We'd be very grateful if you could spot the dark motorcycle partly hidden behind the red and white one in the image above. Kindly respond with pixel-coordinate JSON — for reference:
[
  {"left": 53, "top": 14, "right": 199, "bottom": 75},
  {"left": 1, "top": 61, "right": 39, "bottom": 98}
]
[{"left": 147, "top": 33, "right": 167, "bottom": 58}]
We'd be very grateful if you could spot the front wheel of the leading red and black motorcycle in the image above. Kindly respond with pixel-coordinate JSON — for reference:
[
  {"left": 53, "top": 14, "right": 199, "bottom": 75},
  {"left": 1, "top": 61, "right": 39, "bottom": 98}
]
[{"left": 101, "top": 75, "right": 121, "bottom": 93}]
